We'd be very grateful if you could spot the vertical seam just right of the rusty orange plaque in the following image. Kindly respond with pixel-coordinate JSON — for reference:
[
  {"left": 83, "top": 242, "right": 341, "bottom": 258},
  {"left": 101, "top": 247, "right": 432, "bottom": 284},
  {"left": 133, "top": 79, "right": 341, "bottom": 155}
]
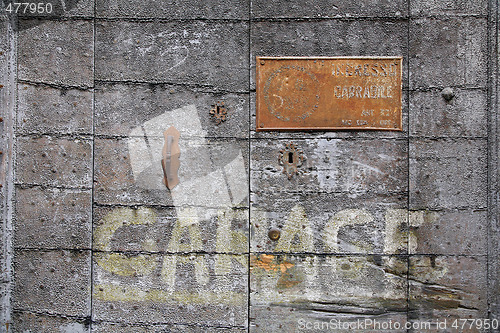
[{"left": 405, "top": 0, "right": 411, "bottom": 331}]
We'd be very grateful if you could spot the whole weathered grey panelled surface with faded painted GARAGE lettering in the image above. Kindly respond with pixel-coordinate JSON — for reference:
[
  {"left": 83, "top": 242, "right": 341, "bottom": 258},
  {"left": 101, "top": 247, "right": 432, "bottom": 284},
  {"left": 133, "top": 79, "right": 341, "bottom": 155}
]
[{"left": 0, "top": 0, "right": 500, "bottom": 332}]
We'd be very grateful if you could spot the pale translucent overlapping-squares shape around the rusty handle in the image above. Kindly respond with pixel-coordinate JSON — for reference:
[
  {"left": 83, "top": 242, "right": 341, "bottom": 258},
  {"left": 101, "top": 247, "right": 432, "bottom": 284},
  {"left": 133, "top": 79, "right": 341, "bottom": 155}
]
[{"left": 128, "top": 105, "right": 248, "bottom": 218}]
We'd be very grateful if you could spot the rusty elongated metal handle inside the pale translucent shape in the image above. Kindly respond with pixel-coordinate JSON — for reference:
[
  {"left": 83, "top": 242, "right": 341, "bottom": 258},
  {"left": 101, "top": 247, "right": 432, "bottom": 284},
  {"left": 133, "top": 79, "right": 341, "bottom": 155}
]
[{"left": 161, "top": 126, "right": 181, "bottom": 190}]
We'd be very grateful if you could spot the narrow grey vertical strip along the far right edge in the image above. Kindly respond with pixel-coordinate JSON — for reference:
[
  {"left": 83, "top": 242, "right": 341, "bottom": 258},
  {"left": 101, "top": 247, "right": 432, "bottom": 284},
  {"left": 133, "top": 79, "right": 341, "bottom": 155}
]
[{"left": 486, "top": 0, "right": 499, "bottom": 326}]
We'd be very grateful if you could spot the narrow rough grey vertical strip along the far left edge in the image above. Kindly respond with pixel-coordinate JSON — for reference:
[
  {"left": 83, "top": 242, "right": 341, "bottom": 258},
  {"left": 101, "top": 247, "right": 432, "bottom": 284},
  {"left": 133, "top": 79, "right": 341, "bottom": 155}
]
[{"left": 0, "top": 16, "right": 17, "bottom": 332}]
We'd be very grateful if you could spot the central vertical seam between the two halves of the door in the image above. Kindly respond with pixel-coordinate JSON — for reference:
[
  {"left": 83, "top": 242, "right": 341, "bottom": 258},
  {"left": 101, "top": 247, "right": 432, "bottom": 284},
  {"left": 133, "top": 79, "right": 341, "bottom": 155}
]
[{"left": 247, "top": 0, "right": 252, "bottom": 332}]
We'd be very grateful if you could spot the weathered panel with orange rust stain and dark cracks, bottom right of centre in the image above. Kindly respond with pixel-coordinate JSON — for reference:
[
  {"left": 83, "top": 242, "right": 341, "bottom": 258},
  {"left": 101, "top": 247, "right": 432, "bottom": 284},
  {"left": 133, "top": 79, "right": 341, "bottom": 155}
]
[{"left": 250, "top": 254, "right": 407, "bottom": 332}]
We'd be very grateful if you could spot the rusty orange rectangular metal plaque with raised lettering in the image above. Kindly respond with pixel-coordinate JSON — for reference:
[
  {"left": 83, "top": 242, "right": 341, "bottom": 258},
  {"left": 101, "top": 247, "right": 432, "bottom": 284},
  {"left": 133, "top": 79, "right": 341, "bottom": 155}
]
[{"left": 257, "top": 57, "right": 403, "bottom": 131}]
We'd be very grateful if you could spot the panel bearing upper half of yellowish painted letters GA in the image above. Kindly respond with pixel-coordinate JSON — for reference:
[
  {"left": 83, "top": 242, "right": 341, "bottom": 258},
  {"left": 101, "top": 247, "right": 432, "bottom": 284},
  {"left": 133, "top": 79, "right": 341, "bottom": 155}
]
[{"left": 93, "top": 207, "right": 248, "bottom": 253}]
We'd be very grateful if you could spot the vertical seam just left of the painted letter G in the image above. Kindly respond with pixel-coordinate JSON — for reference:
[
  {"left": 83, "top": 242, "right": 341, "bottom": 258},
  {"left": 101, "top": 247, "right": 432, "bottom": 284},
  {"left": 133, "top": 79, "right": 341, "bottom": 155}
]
[{"left": 88, "top": 0, "right": 96, "bottom": 332}]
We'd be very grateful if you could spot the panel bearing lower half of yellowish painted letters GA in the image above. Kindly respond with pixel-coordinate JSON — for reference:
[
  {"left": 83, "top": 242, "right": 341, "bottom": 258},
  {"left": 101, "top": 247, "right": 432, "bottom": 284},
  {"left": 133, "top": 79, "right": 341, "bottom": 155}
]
[{"left": 93, "top": 253, "right": 248, "bottom": 327}]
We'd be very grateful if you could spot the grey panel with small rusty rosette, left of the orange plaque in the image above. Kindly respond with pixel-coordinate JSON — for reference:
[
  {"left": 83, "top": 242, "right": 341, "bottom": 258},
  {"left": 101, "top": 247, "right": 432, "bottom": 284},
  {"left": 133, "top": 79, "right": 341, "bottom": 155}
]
[{"left": 95, "top": 84, "right": 249, "bottom": 138}]
